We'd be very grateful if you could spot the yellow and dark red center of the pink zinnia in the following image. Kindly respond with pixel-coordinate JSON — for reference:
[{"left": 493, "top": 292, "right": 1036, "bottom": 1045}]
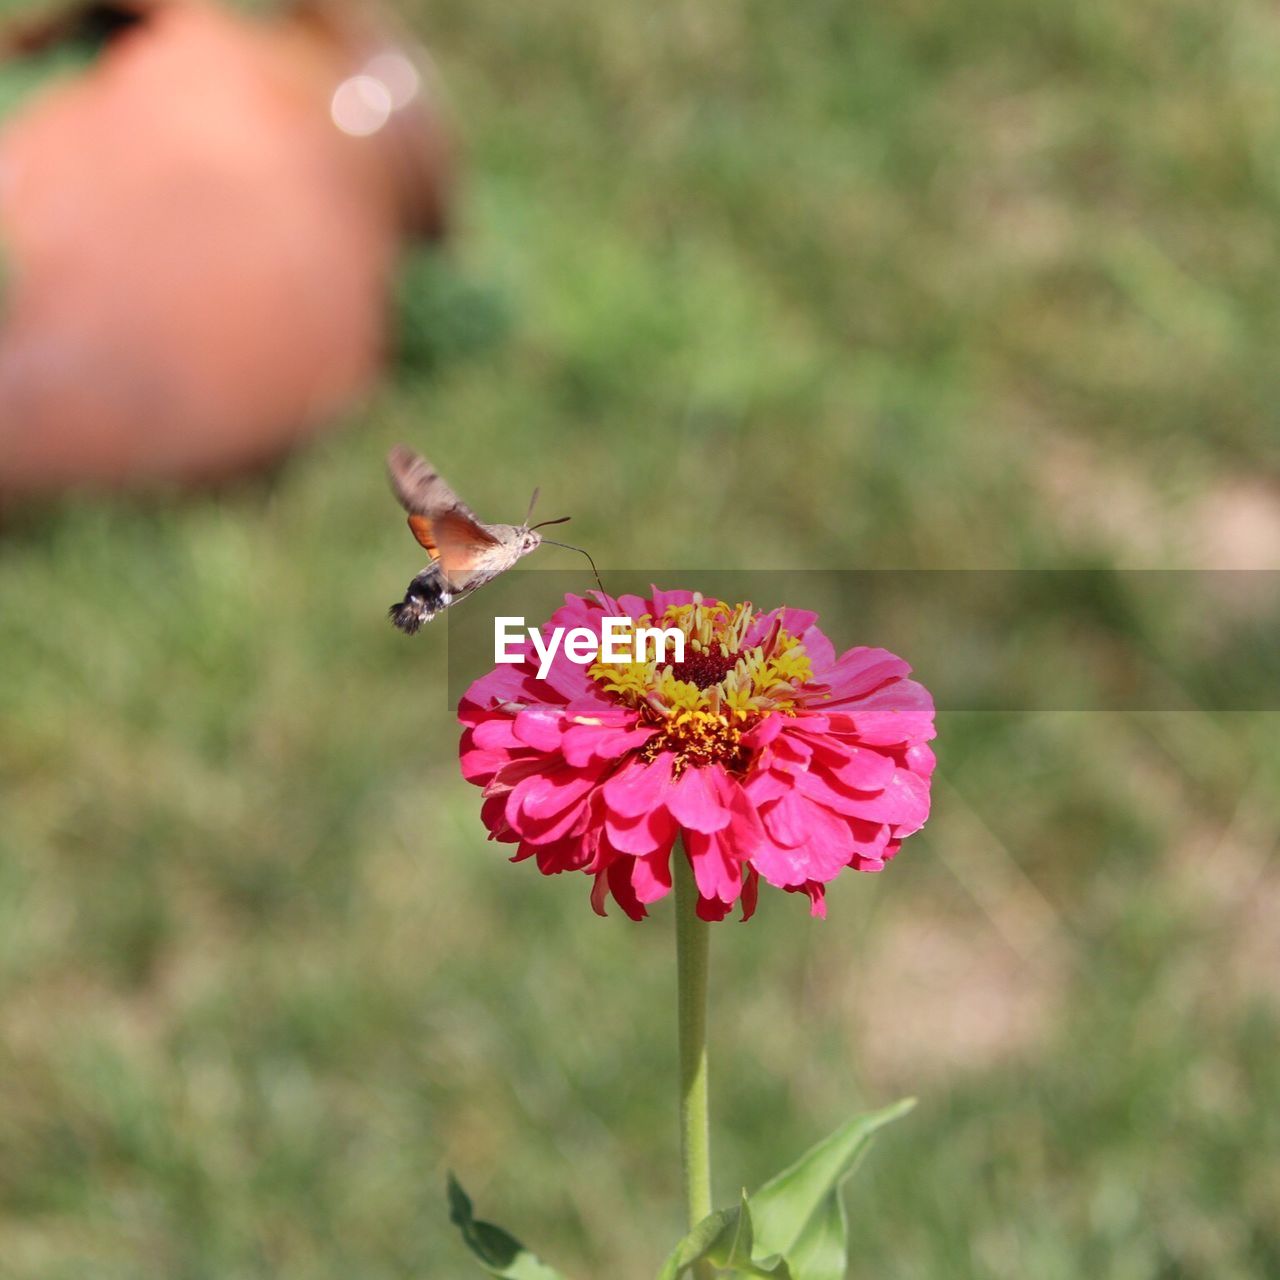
[{"left": 589, "top": 595, "right": 813, "bottom": 773}]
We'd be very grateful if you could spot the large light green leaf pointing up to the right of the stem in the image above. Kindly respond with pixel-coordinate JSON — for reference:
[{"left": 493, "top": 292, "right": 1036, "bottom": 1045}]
[{"left": 749, "top": 1098, "right": 915, "bottom": 1264}]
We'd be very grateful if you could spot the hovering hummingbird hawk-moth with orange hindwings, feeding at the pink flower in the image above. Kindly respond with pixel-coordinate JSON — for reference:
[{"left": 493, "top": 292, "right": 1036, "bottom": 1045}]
[{"left": 387, "top": 444, "right": 604, "bottom": 635}]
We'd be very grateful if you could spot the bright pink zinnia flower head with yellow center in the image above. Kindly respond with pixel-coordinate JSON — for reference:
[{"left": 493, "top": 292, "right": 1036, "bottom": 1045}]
[{"left": 458, "top": 589, "right": 934, "bottom": 920}]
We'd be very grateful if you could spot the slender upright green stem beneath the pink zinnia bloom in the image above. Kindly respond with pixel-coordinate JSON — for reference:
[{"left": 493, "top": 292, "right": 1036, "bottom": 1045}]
[{"left": 675, "top": 845, "right": 712, "bottom": 1280}]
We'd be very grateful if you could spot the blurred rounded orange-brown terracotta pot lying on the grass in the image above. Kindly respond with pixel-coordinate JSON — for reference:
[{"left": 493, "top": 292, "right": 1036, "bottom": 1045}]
[{"left": 0, "top": 0, "right": 452, "bottom": 499}]
